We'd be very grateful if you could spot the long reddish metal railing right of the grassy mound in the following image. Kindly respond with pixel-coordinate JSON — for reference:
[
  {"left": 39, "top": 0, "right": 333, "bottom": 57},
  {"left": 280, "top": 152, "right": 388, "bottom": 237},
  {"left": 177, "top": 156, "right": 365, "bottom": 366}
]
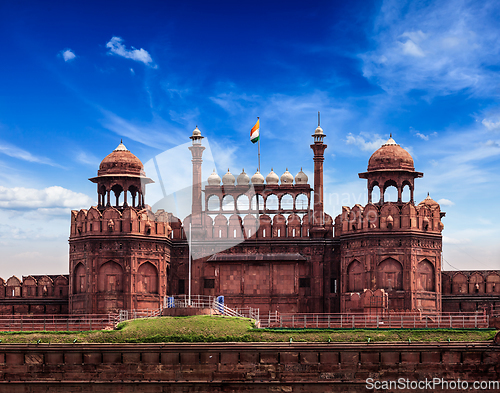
[{"left": 260, "top": 312, "right": 489, "bottom": 329}]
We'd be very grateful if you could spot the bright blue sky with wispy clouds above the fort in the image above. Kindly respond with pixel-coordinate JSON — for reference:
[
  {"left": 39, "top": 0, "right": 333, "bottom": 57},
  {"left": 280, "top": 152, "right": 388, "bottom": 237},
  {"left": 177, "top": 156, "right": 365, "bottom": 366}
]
[{"left": 0, "top": 0, "right": 500, "bottom": 278}]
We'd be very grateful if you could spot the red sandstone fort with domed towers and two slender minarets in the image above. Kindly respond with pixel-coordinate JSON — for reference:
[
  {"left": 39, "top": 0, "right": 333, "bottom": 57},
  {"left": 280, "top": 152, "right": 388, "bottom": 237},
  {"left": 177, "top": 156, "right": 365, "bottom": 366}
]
[{"left": 0, "top": 126, "right": 500, "bottom": 314}]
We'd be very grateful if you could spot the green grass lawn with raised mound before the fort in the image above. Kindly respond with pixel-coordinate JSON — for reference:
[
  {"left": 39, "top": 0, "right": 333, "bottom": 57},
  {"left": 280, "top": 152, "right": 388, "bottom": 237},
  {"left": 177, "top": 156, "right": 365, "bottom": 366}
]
[{"left": 0, "top": 315, "right": 496, "bottom": 344}]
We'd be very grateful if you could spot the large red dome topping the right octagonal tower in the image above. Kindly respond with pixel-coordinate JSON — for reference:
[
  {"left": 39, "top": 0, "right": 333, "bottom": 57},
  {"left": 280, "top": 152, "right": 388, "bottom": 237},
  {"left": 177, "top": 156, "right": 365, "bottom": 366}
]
[{"left": 368, "top": 135, "right": 415, "bottom": 171}]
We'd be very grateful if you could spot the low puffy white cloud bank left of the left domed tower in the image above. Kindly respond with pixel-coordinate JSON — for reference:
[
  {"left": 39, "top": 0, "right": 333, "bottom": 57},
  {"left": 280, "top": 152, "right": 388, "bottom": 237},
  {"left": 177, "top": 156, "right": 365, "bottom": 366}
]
[{"left": 0, "top": 186, "right": 94, "bottom": 210}]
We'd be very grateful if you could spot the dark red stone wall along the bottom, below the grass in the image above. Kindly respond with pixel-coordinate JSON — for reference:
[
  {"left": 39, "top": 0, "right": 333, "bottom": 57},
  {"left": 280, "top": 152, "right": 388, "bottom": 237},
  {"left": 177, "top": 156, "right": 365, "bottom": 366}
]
[{"left": 0, "top": 343, "right": 500, "bottom": 392}]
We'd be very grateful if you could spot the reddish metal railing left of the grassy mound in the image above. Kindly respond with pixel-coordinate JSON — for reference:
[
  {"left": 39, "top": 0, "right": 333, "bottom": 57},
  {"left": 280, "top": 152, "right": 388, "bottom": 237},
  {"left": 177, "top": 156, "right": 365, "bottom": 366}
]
[{"left": 0, "top": 314, "right": 117, "bottom": 332}]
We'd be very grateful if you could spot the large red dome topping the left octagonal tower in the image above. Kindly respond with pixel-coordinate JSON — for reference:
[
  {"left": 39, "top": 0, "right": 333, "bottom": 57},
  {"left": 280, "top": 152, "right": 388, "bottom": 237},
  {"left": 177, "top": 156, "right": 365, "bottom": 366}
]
[{"left": 97, "top": 142, "right": 146, "bottom": 176}]
